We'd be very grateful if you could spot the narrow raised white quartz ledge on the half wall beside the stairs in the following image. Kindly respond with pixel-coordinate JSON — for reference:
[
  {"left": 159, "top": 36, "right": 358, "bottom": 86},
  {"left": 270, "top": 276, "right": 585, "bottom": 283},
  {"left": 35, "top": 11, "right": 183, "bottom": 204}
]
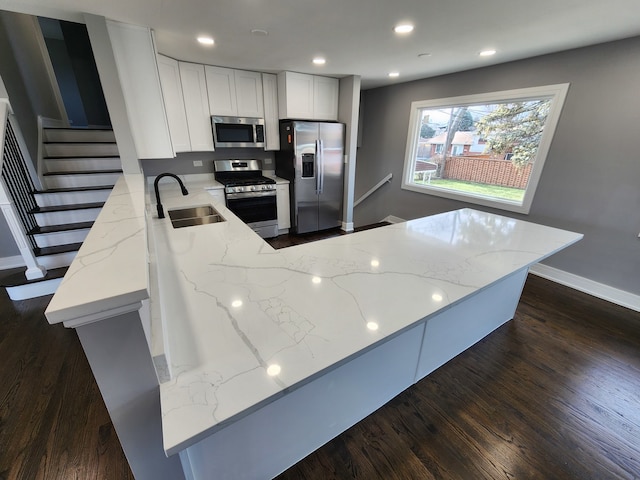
[{"left": 45, "top": 175, "right": 149, "bottom": 327}]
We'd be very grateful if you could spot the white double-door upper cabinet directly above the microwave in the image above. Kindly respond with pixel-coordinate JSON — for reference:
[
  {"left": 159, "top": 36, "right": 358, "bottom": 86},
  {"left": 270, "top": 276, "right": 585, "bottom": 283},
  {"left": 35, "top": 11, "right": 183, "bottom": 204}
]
[{"left": 205, "top": 65, "right": 264, "bottom": 118}]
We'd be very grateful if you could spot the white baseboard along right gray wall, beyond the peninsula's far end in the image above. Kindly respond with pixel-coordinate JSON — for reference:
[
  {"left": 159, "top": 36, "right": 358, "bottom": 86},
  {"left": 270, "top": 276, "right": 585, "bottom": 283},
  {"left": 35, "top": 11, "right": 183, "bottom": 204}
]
[{"left": 529, "top": 263, "right": 640, "bottom": 312}]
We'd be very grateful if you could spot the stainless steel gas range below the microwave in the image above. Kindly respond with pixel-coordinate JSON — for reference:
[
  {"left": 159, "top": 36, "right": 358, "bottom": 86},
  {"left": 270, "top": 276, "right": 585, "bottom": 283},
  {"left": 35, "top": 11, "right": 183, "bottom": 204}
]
[{"left": 213, "top": 159, "right": 278, "bottom": 238}]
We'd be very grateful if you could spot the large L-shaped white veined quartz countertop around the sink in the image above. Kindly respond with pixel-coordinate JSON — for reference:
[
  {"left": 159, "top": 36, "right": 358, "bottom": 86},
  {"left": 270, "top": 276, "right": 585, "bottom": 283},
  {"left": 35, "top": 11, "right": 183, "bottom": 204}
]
[{"left": 148, "top": 176, "right": 582, "bottom": 455}]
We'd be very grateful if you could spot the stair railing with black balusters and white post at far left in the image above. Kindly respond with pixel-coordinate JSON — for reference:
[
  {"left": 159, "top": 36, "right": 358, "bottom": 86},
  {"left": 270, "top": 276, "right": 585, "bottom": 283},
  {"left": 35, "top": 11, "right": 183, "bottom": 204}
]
[{"left": 0, "top": 99, "right": 47, "bottom": 280}]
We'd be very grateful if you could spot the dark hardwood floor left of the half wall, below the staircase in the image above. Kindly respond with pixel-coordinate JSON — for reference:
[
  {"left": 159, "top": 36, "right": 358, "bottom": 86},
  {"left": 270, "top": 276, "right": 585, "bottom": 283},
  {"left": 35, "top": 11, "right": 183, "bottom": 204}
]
[{"left": 0, "top": 289, "right": 133, "bottom": 480}]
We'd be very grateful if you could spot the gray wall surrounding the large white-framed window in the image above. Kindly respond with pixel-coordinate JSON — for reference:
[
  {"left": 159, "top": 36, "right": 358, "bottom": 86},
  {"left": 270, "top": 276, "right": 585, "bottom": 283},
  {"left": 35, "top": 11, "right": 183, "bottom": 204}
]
[{"left": 354, "top": 37, "right": 640, "bottom": 294}]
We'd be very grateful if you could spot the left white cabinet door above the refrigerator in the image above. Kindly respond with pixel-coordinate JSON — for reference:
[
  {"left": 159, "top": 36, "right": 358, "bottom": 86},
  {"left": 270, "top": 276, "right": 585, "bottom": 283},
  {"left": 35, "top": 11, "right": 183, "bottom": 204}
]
[{"left": 278, "top": 72, "right": 314, "bottom": 120}]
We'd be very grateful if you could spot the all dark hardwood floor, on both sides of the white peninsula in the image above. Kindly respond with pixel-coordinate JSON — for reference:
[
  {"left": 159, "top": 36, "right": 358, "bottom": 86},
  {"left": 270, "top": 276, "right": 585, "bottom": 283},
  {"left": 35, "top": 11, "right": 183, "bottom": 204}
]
[{"left": 0, "top": 228, "right": 640, "bottom": 480}]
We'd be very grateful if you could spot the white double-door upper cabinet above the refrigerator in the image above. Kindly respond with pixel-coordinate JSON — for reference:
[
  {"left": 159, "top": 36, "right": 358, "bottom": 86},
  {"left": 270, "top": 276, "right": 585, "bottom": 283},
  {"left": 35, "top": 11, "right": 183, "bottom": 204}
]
[{"left": 278, "top": 72, "right": 339, "bottom": 120}]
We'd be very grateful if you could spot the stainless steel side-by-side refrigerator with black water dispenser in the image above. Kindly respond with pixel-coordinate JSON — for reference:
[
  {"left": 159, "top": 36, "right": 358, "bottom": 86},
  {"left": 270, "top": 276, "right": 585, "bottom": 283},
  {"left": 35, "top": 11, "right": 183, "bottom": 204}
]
[{"left": 276, "top": 120, "right": 345, "bottom": 233}]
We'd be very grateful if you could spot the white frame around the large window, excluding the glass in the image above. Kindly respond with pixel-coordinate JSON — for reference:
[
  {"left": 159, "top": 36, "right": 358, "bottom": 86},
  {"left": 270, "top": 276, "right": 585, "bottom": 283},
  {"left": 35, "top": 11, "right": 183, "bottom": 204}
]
[{"left": 401, "top": 83, "right": 569, "bottom": 214}]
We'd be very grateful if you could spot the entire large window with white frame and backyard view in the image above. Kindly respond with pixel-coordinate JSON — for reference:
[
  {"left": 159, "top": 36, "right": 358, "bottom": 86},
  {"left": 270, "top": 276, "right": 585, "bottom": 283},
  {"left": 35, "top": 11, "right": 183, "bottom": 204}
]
[{"left": 402, "top": 84, "right": 569, "bottom": 213}]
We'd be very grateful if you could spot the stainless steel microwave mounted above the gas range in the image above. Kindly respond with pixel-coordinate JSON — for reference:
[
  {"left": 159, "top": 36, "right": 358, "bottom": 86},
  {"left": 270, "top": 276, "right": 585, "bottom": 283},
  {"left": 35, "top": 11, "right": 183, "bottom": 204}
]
[{"left": 211, "top": 116, "right": 264, "bottom": 148}]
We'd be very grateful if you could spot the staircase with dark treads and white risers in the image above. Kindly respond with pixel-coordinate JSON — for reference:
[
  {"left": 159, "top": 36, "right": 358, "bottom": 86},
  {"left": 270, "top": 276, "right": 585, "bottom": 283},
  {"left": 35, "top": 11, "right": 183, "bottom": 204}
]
[{"left": 0, "top": 128, "right": 122, "bottom": 300}]
